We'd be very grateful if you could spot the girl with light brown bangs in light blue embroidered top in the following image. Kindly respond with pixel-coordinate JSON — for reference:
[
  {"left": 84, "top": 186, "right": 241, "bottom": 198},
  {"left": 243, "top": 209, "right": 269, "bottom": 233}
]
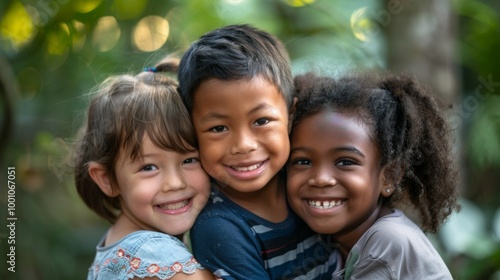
[{"left": 75, "top": 58, "right": 214, "bottom": 279}]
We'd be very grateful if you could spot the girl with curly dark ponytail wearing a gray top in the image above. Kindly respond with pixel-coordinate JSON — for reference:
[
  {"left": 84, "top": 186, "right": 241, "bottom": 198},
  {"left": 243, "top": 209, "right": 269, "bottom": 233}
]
[{"left": 287, "top": 73, "right": 458, "bottom": 279}]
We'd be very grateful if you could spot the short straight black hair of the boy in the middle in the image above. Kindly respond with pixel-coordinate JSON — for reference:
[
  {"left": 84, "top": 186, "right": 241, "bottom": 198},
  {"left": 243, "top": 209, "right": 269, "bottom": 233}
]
[{"left": 178, "top": 25, "right": 293, "bottom": 112}]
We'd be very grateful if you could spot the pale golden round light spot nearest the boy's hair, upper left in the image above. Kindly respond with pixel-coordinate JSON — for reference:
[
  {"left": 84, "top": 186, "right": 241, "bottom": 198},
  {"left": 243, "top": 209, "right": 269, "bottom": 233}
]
[{"left": 132, "top": 16, "right": 170, "bottom": 52}]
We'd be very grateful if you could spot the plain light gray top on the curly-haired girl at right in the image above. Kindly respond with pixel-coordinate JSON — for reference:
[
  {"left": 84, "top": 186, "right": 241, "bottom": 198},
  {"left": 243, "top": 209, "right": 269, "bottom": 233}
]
[{"left": 332, "top": 209, "right": 453, "bottom": 280}]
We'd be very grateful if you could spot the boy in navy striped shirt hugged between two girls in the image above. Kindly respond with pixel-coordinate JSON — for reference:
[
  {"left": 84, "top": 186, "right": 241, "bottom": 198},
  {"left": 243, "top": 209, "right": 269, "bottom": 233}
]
[{"left": 179, "top": 25, "right": 337, "bottom": 280}]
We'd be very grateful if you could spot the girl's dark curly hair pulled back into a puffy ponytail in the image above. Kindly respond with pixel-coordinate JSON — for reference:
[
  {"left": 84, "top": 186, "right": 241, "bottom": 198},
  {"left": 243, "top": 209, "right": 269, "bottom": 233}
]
[{"left": 292, "top": 71, "right": 459, "bottom": 232}]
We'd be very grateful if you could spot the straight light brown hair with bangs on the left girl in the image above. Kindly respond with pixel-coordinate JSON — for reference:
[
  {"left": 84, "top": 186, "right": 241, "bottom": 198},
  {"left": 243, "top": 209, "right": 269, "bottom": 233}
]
[{"left": 72, "top": 59, "right": 197, "bottom": 223}]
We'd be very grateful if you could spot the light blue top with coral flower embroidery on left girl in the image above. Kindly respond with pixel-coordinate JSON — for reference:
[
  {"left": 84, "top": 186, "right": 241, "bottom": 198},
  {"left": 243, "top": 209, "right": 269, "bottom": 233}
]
[{"left": 87, "top": 230, "right": 203, "bottom": 280}]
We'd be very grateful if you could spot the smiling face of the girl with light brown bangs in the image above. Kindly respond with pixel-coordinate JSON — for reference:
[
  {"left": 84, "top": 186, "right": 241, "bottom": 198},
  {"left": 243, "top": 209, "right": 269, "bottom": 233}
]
[{"left": 115, "top": 135, "right": 210, "bottom": 235}]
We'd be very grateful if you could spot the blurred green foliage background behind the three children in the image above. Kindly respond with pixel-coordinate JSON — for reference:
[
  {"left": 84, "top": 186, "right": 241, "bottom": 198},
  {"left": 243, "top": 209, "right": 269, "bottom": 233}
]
[{"left": 0, "top": 0, "right": 500, "bottom": 279}]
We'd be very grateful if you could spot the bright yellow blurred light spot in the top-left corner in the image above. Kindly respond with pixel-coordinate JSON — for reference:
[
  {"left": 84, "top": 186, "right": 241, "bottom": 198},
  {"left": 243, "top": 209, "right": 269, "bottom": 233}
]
[{"left": 0, "top": 2, "right": 36, "bottom": 52}]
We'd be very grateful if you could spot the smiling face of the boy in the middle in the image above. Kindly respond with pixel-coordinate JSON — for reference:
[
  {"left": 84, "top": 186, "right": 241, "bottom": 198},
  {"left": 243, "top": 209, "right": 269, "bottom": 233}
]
[{"left": 192, "top": 76, "right": 290, "bottom": 194}]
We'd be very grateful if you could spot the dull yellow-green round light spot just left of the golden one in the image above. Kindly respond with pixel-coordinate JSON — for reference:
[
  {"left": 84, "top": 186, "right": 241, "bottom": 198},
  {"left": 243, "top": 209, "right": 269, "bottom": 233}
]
[{"left": 92, "top": 16, "right": 121, "bottom": 52}]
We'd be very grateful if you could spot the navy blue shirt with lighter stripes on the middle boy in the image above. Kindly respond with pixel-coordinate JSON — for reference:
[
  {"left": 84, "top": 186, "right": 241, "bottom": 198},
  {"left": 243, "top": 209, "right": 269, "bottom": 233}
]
[{"left": 190, "top": 189, "right": 340, "bottom": 280}]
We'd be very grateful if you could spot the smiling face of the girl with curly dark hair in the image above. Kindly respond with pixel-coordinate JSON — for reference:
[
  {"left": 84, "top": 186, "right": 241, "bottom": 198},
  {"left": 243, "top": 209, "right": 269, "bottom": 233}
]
[{"left": 287, "top": 111, "right": 385, "bottom": 247}]
